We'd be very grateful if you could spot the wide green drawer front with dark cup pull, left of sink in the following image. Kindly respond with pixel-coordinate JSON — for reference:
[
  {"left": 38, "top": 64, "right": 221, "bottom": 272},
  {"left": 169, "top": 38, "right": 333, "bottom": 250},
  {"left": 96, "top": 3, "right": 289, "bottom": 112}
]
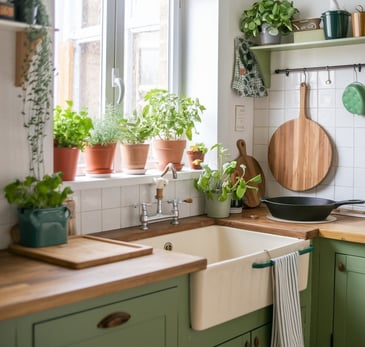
[{"left": 33, "top": 288, "right": 178, "bottom": 347}]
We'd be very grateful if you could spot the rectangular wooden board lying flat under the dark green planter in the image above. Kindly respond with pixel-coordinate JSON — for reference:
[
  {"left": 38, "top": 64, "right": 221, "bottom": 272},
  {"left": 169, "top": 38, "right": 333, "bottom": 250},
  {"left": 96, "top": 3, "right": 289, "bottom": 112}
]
[{"left": 9, "top": 235, "right": 153, "bottom": 269}]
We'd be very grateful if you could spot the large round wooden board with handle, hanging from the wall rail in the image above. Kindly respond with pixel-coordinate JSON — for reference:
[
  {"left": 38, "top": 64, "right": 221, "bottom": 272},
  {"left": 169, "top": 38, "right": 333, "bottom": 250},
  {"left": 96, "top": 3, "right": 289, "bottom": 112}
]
[{"left": 268, "top": 83, "right": 333, "bottom": 191}]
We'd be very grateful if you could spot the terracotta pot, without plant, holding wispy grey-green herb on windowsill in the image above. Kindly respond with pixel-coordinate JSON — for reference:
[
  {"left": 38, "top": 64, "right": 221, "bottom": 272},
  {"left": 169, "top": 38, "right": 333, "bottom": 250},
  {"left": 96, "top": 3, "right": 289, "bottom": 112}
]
[{"left": 85, "top": 143, "right": 117, "bottom": 176}]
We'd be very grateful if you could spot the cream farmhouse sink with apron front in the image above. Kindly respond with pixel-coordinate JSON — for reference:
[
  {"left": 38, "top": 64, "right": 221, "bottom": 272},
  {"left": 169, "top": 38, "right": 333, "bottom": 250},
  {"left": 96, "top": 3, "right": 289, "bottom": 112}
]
[{"left": 138, "top": 225, "right": 310, "bottom": 330}]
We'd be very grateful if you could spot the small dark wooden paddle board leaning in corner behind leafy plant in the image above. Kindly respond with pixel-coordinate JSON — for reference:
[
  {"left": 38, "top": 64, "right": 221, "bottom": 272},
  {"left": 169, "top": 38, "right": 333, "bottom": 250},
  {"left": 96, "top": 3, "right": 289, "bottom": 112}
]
[{"left": 234, "top": 139, "right": 265, "bottom": 207}]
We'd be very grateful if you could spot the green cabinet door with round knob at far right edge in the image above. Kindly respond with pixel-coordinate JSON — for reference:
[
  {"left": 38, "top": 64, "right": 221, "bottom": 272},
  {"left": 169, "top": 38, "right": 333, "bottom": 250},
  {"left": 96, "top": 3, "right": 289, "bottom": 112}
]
[{"left": 333, "top": 254, "right": 365, "bottom": 347}]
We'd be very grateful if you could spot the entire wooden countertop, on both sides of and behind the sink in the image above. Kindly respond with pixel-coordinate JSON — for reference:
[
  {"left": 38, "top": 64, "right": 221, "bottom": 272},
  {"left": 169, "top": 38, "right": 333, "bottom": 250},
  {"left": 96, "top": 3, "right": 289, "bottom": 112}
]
[{"left": 0, "top": 207, "right": 365, "bottom": 320}]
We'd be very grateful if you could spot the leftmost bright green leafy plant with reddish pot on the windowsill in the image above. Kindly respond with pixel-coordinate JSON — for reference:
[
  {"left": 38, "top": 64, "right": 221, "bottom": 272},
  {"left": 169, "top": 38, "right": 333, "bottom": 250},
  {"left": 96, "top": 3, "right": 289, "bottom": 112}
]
[{"left": 53, "top": 100, "right": 93, "bottom": 181}]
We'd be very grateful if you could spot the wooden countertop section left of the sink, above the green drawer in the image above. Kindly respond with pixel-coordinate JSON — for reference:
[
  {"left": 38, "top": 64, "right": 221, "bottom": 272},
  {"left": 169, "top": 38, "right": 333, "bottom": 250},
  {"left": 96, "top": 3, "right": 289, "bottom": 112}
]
[{"left": 0, "top": 249, "right": 207, "bottom": 320}]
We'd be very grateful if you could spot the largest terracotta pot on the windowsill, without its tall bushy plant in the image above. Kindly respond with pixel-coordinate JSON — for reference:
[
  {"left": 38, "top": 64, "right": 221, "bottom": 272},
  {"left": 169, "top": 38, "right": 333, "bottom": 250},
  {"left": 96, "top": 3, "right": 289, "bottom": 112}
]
[{"left": 153, "top": 140, "right": 186, "bottom": 171}]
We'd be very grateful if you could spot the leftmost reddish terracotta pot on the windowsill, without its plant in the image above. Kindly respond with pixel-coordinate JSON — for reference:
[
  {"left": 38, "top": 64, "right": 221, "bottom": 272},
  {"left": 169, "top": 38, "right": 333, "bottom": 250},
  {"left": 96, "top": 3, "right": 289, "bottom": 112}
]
[{"left": 53, "top": 147, "right": 80, "bottom": 181}]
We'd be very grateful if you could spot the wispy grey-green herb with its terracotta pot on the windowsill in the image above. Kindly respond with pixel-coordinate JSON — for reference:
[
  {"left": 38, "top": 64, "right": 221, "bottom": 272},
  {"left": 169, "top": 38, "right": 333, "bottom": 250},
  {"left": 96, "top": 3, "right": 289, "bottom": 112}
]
[{"left": 85, "top": 106, "right": 120, "bottom": 177}]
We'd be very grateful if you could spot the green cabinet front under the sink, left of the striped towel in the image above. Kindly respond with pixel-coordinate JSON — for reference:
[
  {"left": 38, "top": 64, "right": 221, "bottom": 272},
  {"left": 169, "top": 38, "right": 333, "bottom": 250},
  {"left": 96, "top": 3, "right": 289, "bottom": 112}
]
[{"left": 217, "top": 324, "right": 271, "bottom": 347}]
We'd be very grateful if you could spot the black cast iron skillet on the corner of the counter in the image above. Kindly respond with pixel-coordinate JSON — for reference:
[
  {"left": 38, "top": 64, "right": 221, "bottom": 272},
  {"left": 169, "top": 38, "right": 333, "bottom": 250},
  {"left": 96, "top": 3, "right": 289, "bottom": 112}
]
[{"left": 261, "top": 196, "right": 365, "bottom": 222}]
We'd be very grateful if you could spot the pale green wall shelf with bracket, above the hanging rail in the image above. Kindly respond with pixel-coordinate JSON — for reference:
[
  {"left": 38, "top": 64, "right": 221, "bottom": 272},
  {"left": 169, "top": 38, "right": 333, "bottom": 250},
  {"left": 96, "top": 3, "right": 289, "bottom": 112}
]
[{"left": 251, "top": 36, "right": 365, "bottom": 88}]
